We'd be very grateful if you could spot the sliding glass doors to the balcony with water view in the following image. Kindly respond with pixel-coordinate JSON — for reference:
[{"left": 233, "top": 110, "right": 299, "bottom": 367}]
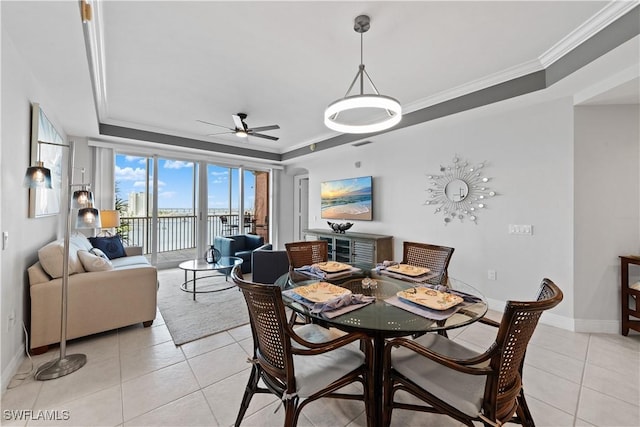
[{"left": 115, "top": 153, "right": 270, "bottom": 267}]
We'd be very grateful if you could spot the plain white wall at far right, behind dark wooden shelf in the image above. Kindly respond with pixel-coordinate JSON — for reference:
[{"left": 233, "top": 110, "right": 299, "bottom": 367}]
[{"left": 574, "top": 105, "right": 640, "bottom": 331}]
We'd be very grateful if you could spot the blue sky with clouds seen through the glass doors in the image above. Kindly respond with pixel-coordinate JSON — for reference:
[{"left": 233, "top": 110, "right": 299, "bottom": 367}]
[{"left": 115, "top": 154, "right": 255, "bottom": 210}]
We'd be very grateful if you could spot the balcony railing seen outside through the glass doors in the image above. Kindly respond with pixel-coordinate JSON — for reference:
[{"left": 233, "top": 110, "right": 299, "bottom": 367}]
[{"left": 120, "top": 215, "right": 266, "bottom": 254}]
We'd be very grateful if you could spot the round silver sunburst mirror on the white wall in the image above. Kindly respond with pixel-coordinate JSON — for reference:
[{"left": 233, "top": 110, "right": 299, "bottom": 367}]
[{"left": 424, "top": 156, "right": 496, "bottom": 225}]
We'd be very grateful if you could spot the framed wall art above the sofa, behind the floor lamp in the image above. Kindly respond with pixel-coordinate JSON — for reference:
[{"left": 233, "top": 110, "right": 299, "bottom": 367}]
[{"left": 29, "top": 102, "right": 65, "bottom": 218}]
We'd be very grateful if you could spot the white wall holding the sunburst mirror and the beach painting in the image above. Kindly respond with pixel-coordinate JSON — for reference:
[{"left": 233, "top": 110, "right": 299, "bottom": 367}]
[{"left": 284, "top": 98, "right": 640, "bottom": 332}]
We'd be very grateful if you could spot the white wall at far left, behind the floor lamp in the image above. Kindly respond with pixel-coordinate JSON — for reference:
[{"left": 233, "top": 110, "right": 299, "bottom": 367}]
[{"left": 0, "top": 25, "right": 62, "bottom": 389}]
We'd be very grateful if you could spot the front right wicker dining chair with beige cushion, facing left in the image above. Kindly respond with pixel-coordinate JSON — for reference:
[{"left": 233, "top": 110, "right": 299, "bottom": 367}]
[{"left": 383, "top": 278, "right": 563, "bottom": 426}]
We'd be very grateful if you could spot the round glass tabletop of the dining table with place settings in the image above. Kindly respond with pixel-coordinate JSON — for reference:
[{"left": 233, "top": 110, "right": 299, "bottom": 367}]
[{"left": 276, "top": 267, "right": 488, "bottom": 337}]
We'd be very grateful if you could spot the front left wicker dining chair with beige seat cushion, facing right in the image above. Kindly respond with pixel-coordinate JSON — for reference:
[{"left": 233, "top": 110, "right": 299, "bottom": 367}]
[{"left": 231, "top": 267, "right": 373, "bottom": 426}]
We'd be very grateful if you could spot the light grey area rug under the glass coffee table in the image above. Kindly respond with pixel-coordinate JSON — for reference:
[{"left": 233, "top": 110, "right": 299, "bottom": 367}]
[{"left": 158, "top": 268, "right": 249, "bottom": 345}]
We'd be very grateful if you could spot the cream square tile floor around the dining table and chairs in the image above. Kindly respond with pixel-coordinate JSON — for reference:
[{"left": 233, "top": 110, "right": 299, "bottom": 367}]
[{"left": 0, "top": 313, "right": 640, "bottom": 427}]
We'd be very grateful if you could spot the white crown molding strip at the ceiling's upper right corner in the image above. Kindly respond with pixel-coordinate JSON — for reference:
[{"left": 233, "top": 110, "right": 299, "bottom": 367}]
[{"left": 538, "top": 1, "right": 638, "bottom": 68}]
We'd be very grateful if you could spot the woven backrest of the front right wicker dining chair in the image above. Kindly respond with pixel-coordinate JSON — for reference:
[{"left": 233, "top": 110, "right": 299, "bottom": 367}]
[{"left": 484, "top": 278, "right": 563, "bottom": 420}]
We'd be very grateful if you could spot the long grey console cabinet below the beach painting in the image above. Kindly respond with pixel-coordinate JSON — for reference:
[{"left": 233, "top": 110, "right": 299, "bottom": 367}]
[{"left": 303, "top": 229, "right": 393, "bottom": 265}]
